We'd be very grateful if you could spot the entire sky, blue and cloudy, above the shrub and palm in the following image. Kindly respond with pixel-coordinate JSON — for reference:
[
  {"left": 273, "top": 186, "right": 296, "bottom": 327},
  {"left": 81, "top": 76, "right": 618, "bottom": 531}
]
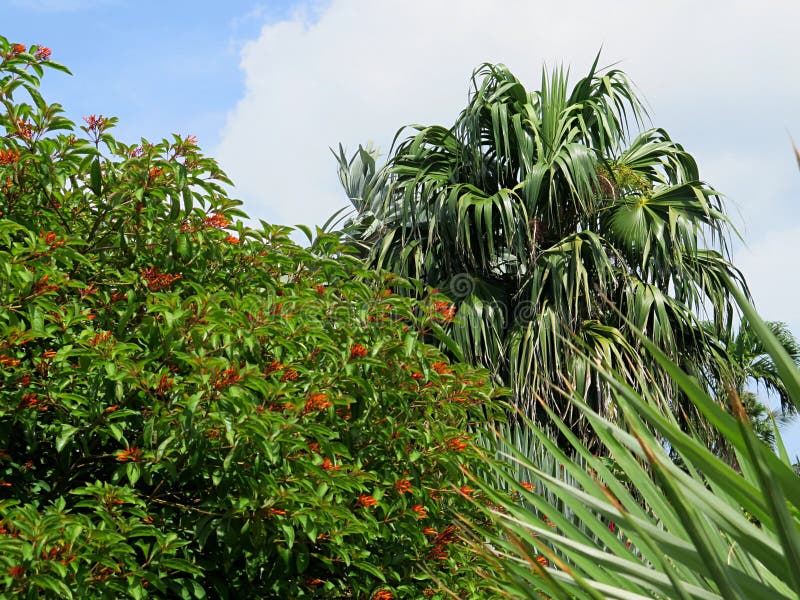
[{"left": 0, "top": 0, "right": 800, "bottom": 453}]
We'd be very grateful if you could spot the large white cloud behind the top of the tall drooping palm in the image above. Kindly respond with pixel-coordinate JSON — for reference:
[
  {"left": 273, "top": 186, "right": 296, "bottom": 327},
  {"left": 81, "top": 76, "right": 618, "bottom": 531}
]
[{"left": 217, "top": 0, "right": 800, "bottom": 232}]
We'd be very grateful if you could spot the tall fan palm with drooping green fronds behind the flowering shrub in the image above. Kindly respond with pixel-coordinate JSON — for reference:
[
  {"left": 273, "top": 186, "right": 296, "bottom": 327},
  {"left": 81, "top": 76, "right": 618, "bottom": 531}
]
[{"left": 337, "top": 60, "right": 746, "bottom": 440}]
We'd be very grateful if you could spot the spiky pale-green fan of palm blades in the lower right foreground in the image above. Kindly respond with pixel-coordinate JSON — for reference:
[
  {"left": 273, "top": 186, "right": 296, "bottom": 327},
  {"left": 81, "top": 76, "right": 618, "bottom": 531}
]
[{"left": 466, "top": 292, "right": 800, "bottom": 599}]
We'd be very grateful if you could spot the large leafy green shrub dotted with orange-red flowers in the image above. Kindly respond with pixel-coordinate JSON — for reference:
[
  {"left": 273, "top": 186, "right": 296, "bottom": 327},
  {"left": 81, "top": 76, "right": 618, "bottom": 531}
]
[{"left": 0, "top": 37, "right": 500, "bottom": 600}]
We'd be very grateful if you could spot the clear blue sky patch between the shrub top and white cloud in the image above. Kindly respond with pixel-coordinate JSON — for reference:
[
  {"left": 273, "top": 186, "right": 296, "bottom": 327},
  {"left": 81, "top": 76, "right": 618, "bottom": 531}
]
[{"left": 0, "top": 0, "right": 300, "bottom": 149}]
